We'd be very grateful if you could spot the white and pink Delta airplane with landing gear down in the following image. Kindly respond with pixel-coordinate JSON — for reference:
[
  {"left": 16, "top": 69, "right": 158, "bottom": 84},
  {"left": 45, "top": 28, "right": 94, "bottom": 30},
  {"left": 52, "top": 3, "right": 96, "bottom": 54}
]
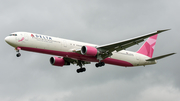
[{"left": 5, "top": 29, "right": 175, "bottom": 73}]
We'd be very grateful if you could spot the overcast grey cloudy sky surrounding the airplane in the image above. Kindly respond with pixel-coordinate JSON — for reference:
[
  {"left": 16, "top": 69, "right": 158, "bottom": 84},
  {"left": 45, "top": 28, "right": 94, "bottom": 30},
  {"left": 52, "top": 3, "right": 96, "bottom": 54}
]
[{"left": 0, "top": 0, "right": 180, "bottom": 101}]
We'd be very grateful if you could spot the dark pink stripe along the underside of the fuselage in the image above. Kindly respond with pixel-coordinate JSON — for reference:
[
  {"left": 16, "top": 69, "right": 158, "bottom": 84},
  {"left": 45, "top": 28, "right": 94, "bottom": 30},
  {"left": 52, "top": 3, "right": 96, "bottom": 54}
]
[{"left": 19, "top": 47, "right": 133, "bottom": 67}]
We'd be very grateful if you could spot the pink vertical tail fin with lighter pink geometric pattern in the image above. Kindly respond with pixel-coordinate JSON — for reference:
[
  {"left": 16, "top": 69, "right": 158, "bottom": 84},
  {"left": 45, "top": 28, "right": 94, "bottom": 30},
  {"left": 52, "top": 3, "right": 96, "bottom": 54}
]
[{"left": 137, "top": 34, "right": 158, "bottom": 58}]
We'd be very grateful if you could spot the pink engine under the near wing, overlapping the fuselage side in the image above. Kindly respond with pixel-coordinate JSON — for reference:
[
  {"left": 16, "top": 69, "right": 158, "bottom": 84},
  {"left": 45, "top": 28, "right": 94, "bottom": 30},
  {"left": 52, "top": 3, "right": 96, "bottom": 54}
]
[{"left": 81, "top": 46, "right": 98, "bottom": 56}]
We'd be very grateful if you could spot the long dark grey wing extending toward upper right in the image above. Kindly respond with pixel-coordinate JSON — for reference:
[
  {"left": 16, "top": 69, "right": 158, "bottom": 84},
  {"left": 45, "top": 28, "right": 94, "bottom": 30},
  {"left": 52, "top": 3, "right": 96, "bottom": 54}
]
[{"left": 97, "top": 29, "right": 170, "bottom": 53}]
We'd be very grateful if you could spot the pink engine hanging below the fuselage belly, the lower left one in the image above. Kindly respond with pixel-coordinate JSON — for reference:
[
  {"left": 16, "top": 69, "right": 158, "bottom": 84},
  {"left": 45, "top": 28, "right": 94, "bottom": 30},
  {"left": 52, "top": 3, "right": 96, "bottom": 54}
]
[{"left": 50, "top": 57, "right": 70, "bottom": 66}]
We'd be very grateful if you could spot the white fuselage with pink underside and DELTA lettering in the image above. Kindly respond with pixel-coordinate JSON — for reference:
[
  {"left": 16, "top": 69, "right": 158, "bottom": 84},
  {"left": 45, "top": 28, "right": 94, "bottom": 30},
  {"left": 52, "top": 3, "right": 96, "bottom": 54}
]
[{"left": 5, "top": 32, "right": 156, "bottom": 67}]
